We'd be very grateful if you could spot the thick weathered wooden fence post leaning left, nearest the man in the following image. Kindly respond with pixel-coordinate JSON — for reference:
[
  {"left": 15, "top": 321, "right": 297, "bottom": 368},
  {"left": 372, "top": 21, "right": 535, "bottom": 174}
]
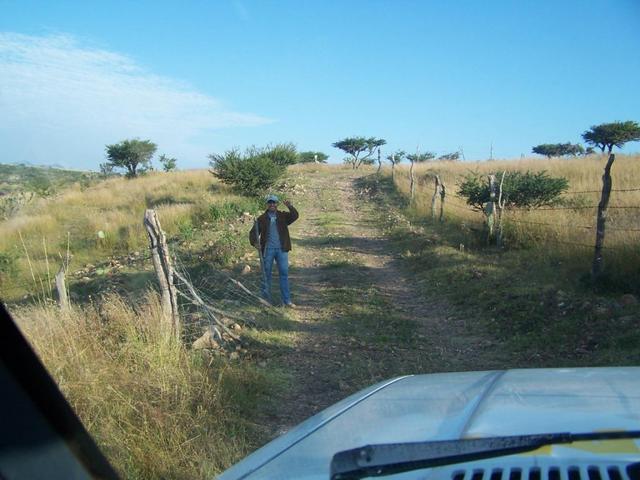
[{"left": 144, "top": 209, "right": 180, "bottom": 339}]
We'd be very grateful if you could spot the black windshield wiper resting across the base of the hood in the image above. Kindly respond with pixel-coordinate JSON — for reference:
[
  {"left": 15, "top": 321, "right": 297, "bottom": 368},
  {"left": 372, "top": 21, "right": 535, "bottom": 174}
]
[{"left": 331, "top": 430, "right": 640, "bottom": 480}]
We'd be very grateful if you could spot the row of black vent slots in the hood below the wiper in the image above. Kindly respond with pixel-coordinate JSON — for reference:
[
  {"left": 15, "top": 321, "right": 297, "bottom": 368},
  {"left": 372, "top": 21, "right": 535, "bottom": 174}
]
[{"left": 451, "top": 463, "right": 640, "bottom": 480}]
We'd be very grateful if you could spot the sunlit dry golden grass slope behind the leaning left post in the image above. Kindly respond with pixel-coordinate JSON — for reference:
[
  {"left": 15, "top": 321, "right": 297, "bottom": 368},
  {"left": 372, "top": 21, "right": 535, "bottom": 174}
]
[{"left": 0, "top": 170, "right": 255, "bottom": 299}]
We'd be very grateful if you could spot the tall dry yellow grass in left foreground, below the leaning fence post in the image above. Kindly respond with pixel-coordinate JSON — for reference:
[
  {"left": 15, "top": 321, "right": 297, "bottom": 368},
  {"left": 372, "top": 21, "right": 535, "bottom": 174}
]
[{"left": 13, "top": 293, "right": 264, "bottom": 479}]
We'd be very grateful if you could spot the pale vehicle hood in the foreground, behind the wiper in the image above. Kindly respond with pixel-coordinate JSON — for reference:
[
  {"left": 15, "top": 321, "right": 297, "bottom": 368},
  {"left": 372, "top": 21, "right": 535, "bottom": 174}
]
[{"left": 219, "top": 367, "right": 640, "bottom": 480}]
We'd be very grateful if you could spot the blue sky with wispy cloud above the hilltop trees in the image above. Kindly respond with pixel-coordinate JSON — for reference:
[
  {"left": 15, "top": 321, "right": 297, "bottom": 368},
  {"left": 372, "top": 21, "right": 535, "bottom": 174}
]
[{"left": 0, "top": 0, "right": 640, "bottom": 169}]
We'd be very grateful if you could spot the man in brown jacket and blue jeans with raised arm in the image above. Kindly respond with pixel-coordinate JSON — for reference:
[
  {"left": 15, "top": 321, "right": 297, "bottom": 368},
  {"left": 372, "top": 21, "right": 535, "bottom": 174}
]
[{"left": 249, "top": 195, "right": 298, "bottom": 308}]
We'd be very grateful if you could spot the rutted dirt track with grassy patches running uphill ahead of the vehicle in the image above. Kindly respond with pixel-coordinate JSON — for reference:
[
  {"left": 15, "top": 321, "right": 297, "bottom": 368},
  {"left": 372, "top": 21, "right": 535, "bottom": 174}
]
[{"left": 254, "top": 169, "right": 491, "bottom": 436}]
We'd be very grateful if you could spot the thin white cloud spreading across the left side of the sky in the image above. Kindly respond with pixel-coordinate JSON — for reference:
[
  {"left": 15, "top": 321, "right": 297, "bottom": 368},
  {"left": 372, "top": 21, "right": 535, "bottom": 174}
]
[{"left": 0, "top": 32, "right": 272, "bottom": 167}]
